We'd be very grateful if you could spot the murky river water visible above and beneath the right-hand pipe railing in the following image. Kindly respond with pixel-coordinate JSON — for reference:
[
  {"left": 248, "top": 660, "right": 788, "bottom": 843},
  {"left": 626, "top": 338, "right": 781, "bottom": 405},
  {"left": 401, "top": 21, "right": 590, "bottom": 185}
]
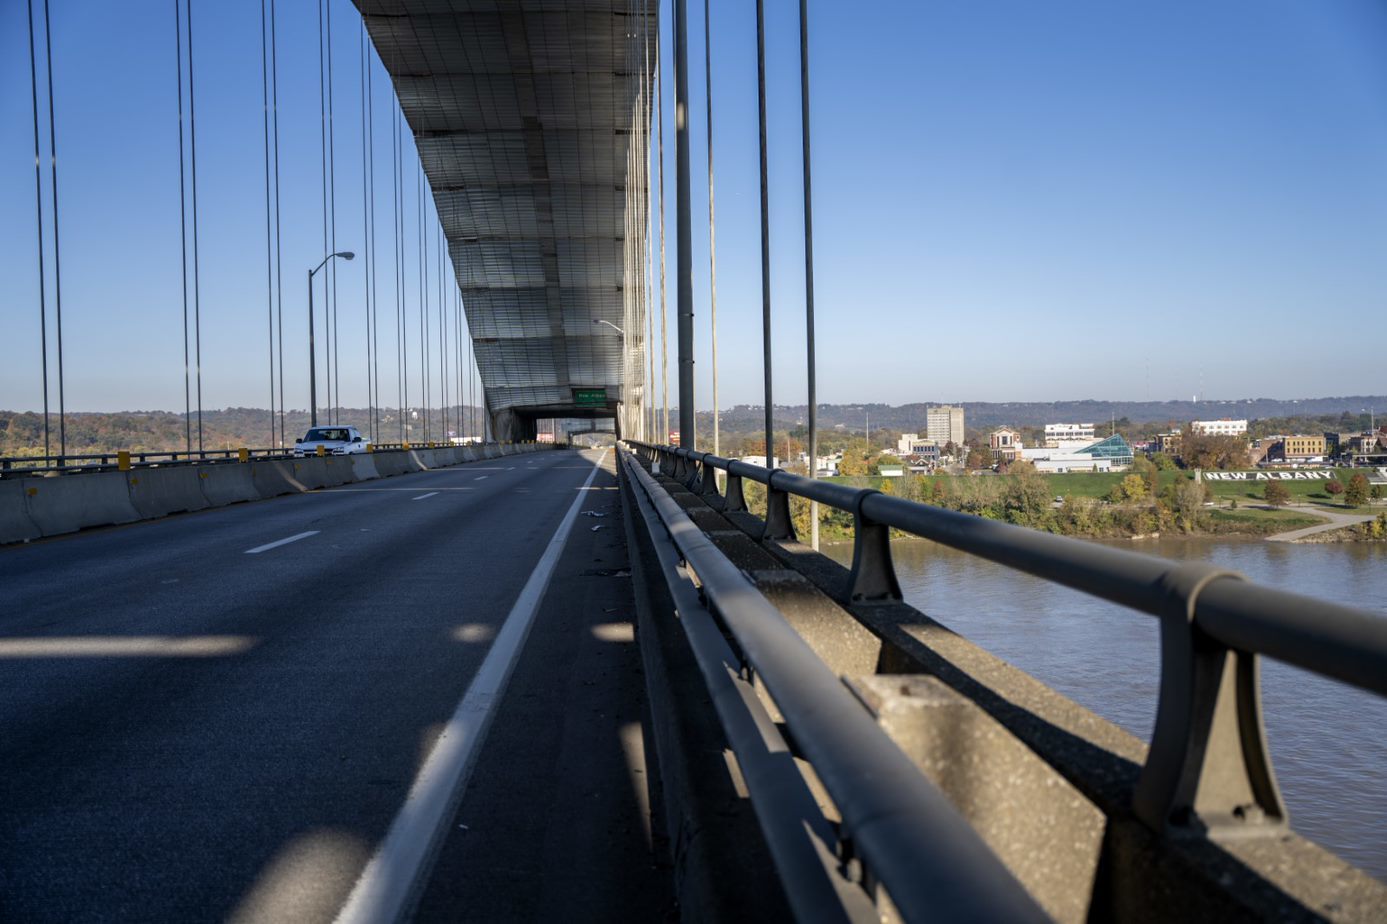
[{"left": 824, "top": 538, "right": 1387, "bottom": 881}]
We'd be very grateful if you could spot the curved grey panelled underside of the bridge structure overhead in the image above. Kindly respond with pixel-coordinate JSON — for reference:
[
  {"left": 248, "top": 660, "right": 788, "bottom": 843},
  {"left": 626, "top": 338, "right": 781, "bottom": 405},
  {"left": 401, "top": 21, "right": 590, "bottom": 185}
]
[{"left": 356, "top": 0, "right": 657, "bottom": 438}]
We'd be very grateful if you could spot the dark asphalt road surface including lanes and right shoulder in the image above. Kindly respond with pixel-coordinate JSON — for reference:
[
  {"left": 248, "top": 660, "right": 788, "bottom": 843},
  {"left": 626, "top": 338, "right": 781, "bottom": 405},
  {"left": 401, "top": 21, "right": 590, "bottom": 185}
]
[{"left": 0, "top": 443, "right": 673, "bottom": 921}]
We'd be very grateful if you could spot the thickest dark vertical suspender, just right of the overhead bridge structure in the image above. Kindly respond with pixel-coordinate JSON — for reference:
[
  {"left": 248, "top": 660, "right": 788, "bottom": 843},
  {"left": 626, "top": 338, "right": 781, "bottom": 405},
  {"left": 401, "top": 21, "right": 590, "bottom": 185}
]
[{"left": 674, "top": 0, "right": 698, "bottom": 450}]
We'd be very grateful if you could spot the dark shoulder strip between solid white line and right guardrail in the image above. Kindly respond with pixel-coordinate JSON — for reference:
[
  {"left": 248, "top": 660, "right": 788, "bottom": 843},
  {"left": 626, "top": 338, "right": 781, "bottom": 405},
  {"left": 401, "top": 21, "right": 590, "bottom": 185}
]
[{"left": 407, "top": 454, "right": 675, "bottom": 921}]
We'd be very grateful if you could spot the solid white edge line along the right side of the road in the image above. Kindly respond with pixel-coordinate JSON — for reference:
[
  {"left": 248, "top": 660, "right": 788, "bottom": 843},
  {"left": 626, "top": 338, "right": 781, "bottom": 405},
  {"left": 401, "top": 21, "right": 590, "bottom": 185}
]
[{"left": 337, "top": 452, "right": 606, "bottom": 924}]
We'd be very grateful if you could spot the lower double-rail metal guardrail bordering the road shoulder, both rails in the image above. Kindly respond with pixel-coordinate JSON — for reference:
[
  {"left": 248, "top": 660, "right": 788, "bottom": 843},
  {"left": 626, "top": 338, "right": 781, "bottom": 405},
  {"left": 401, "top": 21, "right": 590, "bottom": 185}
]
[{"left": 621, "top": 443, "right": 1046, "bottom": 921}]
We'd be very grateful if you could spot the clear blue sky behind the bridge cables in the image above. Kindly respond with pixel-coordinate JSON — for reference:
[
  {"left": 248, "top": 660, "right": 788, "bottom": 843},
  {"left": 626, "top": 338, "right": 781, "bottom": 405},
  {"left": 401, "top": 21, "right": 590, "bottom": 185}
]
[{"left": 0, "top": 0, "right": 1387, "bottom": 411}]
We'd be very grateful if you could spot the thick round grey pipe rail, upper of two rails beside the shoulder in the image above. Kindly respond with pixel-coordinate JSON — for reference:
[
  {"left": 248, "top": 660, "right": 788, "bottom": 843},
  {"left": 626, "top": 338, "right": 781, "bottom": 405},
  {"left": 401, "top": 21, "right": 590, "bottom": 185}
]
[{"left": 615, "top": 443, "right": 1044, "bottom": 921}]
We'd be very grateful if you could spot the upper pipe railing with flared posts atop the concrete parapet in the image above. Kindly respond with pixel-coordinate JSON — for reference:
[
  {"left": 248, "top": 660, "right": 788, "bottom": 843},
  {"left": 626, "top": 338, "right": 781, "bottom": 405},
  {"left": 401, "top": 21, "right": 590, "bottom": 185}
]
[{"left": 628, "top": 441, "right": 1387, "bottom": 837}]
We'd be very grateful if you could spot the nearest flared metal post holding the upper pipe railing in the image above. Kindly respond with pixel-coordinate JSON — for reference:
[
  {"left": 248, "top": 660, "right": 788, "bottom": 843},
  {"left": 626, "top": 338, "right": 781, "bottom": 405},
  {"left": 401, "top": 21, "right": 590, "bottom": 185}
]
[{"left": 1132, "top": 563, "right": 1287, "bottom": 837}]
